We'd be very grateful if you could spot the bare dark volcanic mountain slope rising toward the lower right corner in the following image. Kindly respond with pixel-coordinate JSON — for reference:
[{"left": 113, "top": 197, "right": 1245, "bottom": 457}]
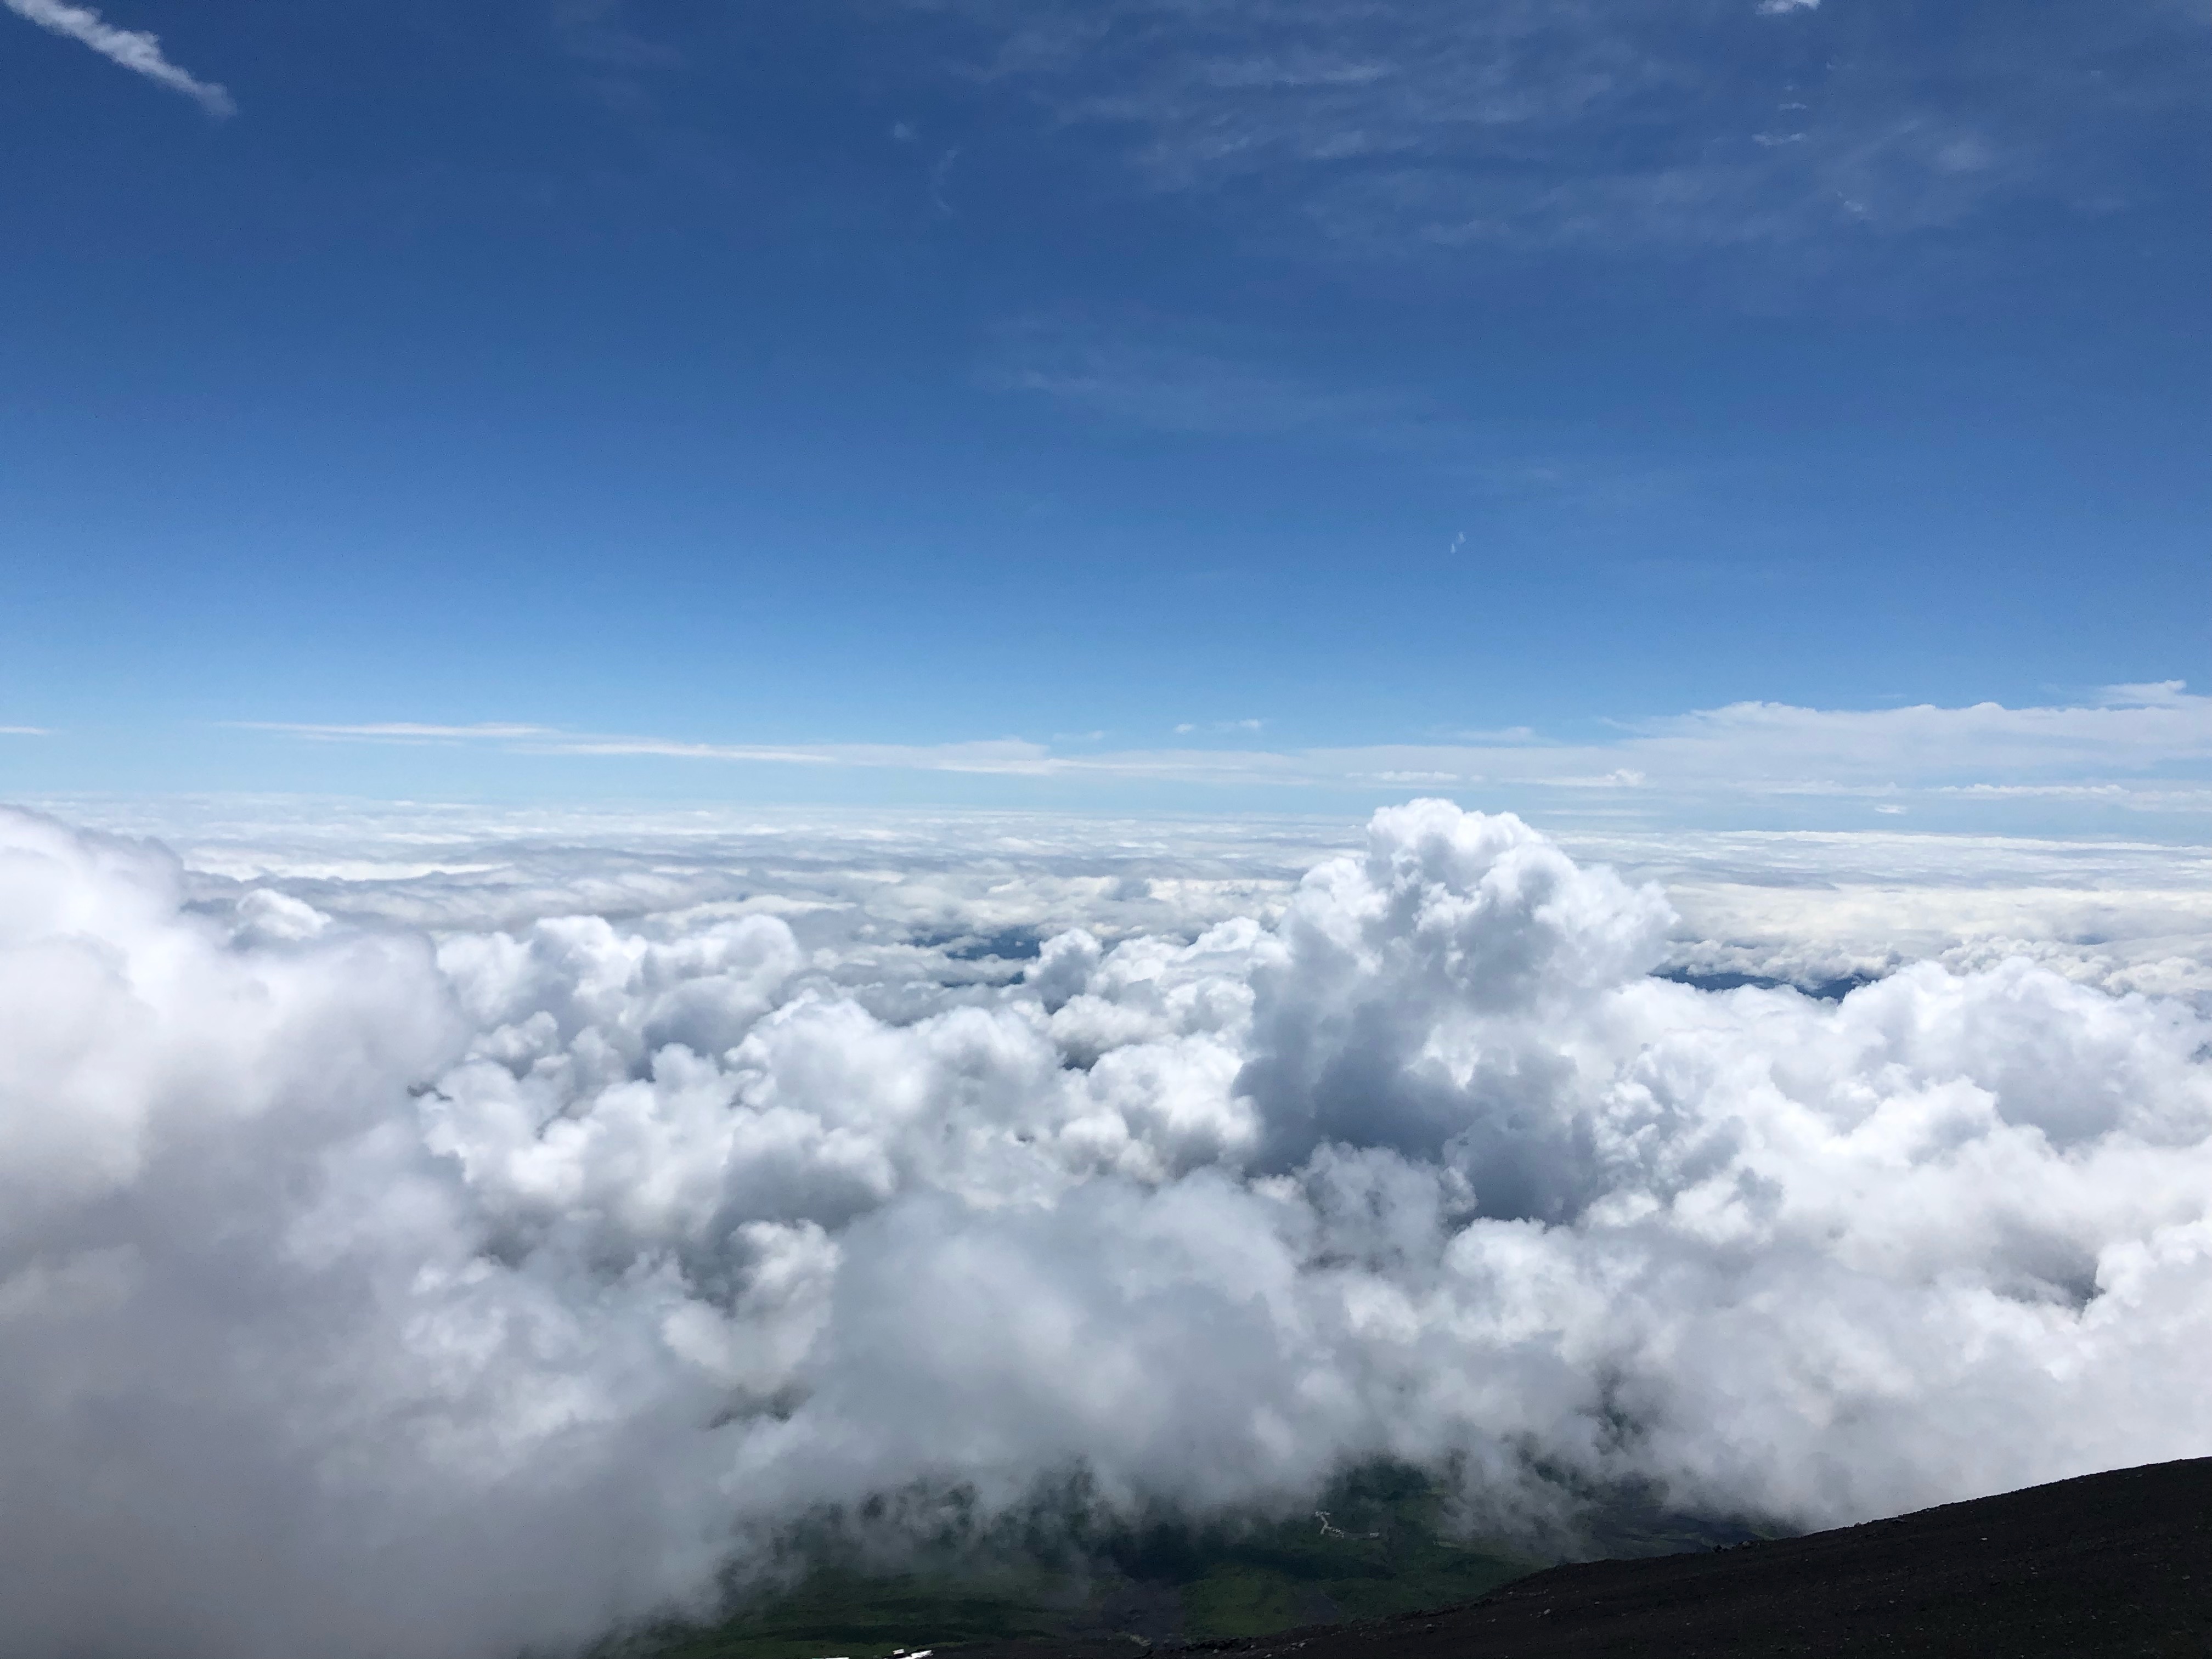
[{"left": 960, "top": 1458, "right": 2212, "bottom": 1659}]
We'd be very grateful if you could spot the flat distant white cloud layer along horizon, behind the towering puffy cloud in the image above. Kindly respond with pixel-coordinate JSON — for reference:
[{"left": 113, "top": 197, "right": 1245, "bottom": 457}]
[{"left": 51, "top": 794, "right": 2212, "bottom": 993}]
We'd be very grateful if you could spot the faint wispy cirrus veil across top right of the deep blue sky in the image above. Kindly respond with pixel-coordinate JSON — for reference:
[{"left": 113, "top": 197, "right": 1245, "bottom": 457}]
[{"left": 913, "top": 0, "right": 2205, "bottom": 255}]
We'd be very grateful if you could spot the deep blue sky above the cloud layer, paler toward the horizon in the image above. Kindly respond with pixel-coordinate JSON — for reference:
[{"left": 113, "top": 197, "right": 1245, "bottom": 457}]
[{"left": 0, "top": 0, "right": 2212, "bottom": 834}]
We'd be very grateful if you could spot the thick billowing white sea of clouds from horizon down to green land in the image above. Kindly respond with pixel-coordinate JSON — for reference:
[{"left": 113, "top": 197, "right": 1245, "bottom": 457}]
[{"left": 0, "top": 801, "right": 2212, "bottom": 1659}]
